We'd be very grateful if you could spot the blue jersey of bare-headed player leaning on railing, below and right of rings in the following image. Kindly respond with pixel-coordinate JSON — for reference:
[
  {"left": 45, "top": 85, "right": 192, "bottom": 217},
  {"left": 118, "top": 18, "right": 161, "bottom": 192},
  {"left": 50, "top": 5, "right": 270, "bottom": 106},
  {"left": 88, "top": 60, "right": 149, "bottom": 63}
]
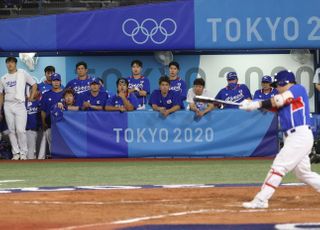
[{"left": 149, "top": 89, "right": 181, "bottom": 109}]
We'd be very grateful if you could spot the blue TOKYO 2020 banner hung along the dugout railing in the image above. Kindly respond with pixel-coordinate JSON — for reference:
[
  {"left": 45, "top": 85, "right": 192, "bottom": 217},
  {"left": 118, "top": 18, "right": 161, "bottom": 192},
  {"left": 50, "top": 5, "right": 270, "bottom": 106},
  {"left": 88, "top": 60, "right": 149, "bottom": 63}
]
[{"left": 52, "top": 110, "right": 278, "bottom": 158}]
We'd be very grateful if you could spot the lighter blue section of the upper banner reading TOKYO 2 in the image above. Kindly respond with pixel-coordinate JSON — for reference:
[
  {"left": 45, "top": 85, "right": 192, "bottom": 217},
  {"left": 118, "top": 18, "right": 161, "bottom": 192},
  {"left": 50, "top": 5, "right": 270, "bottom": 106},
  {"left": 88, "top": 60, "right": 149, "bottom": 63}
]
[{"left": 194, "top": 0, "right": 320, "bottom": 49}]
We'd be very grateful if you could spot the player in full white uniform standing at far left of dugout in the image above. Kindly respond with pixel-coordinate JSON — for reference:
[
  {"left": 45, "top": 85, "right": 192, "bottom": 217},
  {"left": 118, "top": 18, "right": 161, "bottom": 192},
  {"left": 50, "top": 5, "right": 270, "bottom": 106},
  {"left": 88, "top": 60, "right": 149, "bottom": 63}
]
[{"left": 0, "top": 57, "right": 37, "bottom": 160}]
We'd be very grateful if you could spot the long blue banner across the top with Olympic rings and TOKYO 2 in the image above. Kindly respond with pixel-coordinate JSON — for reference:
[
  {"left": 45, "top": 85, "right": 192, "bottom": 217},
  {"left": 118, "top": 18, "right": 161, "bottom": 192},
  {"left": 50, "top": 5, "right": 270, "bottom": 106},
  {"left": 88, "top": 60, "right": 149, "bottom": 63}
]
[{"left": 0, "top": 0, "right": 320, "bottom": 51}]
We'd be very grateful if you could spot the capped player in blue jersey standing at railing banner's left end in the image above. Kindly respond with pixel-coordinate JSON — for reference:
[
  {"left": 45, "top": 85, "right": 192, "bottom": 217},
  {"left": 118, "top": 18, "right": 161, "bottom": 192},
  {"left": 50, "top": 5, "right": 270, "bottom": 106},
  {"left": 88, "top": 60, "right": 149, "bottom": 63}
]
[{"left": 38, "top": 73, "right": 63, "bottom": 159}]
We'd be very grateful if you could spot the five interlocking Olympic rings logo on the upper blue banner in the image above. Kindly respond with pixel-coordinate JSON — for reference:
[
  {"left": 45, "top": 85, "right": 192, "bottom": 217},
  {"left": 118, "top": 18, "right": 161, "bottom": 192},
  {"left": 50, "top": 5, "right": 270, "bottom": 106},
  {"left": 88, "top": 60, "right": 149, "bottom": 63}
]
[{"left": 122, "top": 18, "right": 177, "bottom": 45}]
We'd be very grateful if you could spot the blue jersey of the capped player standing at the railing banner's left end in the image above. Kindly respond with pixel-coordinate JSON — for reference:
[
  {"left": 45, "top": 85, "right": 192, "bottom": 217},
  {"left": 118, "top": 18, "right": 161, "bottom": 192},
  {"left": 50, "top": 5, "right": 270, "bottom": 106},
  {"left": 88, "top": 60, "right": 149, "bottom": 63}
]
[{"left": 40, "top": 90, "right": 63, "bottom": 128}]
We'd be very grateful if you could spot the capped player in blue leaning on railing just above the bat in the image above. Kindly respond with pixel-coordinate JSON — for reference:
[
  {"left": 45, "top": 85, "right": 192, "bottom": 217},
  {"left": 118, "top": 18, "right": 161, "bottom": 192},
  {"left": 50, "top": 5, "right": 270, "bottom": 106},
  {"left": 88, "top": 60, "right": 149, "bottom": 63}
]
[{"left": 216, "top": 72, "right": 252, "bottom": 109}]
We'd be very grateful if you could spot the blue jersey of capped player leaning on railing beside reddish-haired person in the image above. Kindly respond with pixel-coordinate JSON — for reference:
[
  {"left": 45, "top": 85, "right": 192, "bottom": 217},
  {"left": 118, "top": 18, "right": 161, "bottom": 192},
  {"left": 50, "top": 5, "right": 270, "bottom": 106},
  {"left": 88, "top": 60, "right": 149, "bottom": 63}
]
[{"left": 76, "top": 91, "right": 109, "bottom": 111}]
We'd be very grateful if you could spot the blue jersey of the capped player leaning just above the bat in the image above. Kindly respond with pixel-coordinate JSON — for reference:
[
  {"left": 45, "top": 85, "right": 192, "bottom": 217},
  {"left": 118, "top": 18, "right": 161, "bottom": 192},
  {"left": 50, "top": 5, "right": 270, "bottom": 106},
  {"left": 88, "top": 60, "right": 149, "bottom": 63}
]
[{"left": 216, "top": 84, "right": 251, "bottom": 109}]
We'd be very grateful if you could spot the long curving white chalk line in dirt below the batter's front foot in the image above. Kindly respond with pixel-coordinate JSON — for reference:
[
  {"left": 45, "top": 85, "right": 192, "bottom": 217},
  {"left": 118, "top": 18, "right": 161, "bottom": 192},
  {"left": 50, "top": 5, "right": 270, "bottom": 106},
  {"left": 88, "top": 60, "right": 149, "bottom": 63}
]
[{"left": 47, "top": 208, "right": 320, "bottom": 230}]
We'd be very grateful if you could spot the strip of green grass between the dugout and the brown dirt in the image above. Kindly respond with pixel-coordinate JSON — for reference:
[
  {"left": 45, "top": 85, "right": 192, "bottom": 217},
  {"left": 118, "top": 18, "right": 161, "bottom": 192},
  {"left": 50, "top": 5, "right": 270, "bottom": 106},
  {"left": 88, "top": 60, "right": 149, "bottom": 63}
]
[{"left": 0, "top": 159, "right": 320, "bottom": 188}]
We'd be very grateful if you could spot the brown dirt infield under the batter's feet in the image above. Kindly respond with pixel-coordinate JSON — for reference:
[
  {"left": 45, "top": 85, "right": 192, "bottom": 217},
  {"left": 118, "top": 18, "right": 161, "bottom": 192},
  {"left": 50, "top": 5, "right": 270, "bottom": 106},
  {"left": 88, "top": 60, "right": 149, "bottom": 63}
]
[{"left": 0, "top": 186, "right": 320, "bottom": 229}]
